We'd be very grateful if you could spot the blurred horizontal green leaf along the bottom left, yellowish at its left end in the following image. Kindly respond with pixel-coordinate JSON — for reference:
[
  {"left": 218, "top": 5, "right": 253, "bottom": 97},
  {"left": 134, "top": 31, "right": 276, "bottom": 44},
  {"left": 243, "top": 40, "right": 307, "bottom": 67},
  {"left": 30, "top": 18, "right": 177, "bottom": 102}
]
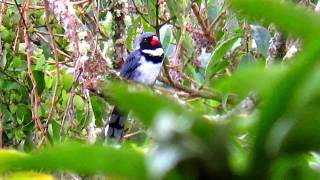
[{"left": 0, "top": 143, "right": 147, "bottom": 179}]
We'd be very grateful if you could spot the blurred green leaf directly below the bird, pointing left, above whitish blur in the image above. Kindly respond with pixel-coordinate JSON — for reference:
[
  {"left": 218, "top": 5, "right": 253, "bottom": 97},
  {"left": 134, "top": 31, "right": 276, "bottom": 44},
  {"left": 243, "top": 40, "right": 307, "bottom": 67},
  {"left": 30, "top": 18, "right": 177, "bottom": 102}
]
[{"left": 102, "top": 83, "right": 215, "bottom": 138}]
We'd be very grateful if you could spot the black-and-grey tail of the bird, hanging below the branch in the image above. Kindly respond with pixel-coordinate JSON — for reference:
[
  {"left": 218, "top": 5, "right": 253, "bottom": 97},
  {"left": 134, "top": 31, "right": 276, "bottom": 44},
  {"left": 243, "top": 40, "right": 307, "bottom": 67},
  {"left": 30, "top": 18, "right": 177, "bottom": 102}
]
[{"left": 107, "top": 107, "right": 127, "bottom": 140}]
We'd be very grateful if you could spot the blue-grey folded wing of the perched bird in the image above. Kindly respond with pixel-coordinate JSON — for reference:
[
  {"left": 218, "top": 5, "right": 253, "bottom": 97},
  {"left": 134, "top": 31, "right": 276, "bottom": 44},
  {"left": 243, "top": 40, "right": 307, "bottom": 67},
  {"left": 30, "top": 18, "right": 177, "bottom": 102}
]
[{"left": 120, "top": 50, "right": 141, "bottom": 80}]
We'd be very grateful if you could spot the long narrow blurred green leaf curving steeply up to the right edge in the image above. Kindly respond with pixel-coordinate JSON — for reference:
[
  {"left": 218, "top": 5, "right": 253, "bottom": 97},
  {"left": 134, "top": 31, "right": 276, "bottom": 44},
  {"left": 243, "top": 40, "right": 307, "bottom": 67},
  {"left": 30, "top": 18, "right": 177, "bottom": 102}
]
[{"left": 252, "top": 42, "right": 320, "bottom": 174}]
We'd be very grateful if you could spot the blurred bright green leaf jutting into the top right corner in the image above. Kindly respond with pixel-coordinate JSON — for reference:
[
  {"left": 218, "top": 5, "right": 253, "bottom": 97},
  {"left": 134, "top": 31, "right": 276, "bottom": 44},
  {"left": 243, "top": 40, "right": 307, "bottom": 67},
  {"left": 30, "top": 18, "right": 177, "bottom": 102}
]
[{"left": 231, "top": 0, "right": 320, "bottom": 40}]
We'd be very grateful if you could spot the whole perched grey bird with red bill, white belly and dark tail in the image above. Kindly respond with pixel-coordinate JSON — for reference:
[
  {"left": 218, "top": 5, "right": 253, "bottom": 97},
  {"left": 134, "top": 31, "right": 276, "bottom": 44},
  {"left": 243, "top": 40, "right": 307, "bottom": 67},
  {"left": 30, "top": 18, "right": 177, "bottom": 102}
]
[{"left": 107, "top": 32, "right": 164, "bottom": 139}]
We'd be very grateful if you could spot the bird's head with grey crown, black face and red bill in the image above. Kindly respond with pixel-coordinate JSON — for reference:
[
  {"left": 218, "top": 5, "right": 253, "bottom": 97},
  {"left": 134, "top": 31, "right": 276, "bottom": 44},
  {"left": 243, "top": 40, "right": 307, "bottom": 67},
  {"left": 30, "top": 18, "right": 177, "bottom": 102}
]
[{"left": 134, "top": 32, "right": 163, "bottom": 56}]
